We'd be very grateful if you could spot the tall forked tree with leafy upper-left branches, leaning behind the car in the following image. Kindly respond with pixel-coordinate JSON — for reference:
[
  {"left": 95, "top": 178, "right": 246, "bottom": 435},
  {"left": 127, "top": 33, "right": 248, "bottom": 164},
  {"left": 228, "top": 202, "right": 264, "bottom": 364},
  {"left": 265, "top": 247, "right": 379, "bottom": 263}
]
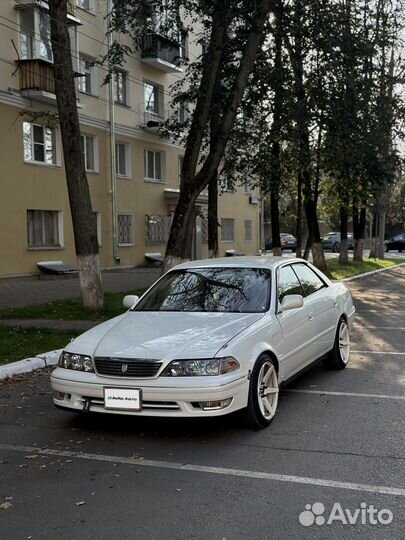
[{"left": 109, "top": 0, "right": 272, "bottom": 270}]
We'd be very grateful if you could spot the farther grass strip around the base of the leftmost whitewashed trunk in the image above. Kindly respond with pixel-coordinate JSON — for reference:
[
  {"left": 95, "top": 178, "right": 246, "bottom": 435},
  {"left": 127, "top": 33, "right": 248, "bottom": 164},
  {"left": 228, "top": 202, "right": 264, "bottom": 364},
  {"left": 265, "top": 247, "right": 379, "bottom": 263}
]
[{"left": 0, "top": 289, "right": 144, "bottom": 321}]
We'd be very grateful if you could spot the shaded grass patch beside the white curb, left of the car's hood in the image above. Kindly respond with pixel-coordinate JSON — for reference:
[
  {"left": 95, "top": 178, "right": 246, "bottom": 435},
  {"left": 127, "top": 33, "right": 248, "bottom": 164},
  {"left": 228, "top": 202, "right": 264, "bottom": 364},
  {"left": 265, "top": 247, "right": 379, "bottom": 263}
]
[{"left": 0, "top": 326, "right": 78, "bottom": 365}]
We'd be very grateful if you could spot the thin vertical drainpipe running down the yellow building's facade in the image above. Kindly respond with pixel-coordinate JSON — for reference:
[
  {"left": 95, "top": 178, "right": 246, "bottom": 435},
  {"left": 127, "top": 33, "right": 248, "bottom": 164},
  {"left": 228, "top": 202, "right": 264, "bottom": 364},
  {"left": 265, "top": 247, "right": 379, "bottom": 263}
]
[{"left": 107, "top": 0, "right": 120, "bottom": 264}]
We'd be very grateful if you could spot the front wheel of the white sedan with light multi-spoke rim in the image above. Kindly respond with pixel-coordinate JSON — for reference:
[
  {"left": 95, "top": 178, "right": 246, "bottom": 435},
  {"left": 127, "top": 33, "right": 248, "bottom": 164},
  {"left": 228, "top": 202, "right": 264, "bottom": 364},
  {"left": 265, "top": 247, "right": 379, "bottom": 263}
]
[{"left": 241, "top": 354, "right": 278, "bottom": 429}]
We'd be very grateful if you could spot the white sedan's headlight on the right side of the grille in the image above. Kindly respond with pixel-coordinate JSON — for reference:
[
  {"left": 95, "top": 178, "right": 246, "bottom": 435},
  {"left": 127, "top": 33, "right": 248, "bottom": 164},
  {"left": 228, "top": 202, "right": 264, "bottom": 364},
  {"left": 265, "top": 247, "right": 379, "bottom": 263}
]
[{"left": 162, "top": 356, "right": 240, "bottom": 377}]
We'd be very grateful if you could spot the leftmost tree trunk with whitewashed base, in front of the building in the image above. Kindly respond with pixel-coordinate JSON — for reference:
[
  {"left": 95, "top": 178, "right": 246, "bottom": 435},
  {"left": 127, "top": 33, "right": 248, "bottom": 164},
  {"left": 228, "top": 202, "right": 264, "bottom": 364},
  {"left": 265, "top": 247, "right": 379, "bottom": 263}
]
[{"left": 49, "top": 0, "right": 103, "bottom": 311}]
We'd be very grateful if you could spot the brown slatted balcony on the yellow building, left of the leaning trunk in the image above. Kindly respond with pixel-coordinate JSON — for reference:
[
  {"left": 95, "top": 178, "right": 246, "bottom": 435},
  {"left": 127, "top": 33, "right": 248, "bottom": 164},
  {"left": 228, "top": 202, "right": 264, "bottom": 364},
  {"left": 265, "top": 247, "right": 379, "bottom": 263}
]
[{"left": 20, "top": 58, "right": 56, "bottom": 105}]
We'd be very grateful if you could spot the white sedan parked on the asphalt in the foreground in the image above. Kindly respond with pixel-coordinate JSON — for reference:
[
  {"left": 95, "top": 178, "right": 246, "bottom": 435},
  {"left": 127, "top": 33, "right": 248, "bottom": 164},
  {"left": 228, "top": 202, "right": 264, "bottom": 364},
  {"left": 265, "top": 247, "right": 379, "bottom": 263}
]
[{"left": 51, "top": 256, "right": 355, "bottom": 428}]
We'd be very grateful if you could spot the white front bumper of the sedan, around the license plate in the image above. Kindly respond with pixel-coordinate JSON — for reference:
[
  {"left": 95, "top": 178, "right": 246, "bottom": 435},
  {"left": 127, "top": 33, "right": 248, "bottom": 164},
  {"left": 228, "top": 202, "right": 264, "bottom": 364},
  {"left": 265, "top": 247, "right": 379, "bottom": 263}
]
[{"left": 51, "top": 368, "right": 249, "bottom": 417}]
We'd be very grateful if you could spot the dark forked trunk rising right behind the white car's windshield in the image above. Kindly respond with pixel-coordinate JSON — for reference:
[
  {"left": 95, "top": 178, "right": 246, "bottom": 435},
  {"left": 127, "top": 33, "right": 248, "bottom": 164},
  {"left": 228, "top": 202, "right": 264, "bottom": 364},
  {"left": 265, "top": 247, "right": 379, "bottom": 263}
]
[{"left": 163, "top": 0, "right": 272, "bottom": 270}]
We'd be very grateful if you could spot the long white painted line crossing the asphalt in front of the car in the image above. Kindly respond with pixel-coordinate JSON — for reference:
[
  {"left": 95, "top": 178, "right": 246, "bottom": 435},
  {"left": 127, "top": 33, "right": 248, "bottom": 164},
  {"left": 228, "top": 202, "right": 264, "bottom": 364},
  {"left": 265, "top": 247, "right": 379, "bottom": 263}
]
[{"left": 0, "top": 443, "right": 405, "bottom": 497}]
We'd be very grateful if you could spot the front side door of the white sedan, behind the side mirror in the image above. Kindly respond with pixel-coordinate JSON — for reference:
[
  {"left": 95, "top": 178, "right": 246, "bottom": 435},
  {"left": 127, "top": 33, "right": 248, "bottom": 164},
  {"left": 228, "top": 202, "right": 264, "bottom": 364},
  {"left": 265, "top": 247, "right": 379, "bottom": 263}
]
[{"left": 276, "top": 264, "right": 315, "bottom": 380}]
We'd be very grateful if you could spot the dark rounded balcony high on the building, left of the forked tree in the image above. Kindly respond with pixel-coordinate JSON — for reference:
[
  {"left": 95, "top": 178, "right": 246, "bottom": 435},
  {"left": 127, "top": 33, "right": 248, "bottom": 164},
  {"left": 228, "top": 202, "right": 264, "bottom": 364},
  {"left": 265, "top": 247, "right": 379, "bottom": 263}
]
[{"left": 141, "top": 34, "right": 184, "bottom": 73}]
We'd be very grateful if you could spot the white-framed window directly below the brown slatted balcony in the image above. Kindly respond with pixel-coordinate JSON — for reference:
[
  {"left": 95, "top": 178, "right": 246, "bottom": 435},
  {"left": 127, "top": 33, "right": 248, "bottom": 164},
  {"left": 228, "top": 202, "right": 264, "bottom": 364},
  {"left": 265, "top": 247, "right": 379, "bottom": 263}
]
[{"left": 23, "top": 122, "right": 56, "bottom": 165}]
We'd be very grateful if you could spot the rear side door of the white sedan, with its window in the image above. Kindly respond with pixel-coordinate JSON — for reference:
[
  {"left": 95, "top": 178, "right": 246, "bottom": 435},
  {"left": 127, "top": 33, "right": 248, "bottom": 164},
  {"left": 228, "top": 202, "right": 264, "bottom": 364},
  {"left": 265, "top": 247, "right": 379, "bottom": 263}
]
[{"left": 292, "top": 262, "right": 338, "bottom": 359}]
